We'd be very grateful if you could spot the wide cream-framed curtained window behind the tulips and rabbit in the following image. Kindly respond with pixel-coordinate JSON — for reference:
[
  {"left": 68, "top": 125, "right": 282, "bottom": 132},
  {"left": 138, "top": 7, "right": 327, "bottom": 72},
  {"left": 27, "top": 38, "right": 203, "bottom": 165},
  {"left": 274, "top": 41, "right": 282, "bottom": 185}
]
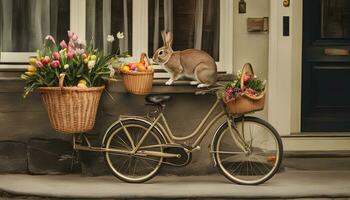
[{"left": 0, "top": 0, "right": 233, "bottom": 72}]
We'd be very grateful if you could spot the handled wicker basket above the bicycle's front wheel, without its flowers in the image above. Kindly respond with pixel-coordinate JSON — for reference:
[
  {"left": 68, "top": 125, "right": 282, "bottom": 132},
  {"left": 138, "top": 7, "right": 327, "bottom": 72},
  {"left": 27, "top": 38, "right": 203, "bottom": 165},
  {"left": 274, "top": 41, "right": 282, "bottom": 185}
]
[{"left": 223, "top": 63, "right": 266, "bottom": 114}]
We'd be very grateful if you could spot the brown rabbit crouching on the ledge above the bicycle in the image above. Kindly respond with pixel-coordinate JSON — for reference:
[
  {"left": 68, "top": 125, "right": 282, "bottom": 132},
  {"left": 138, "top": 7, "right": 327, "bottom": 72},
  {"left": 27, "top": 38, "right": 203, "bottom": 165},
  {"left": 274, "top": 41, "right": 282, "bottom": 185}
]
[{"left": 153, "top": 31, "right": 217, "bottom": 88}]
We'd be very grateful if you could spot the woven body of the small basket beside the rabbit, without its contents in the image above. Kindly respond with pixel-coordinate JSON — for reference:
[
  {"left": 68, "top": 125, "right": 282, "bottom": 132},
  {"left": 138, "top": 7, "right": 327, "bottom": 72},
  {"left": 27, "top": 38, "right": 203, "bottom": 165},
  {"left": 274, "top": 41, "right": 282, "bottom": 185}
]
[{"left": 123, "top": 71, "right": 154, "bottom": 95}]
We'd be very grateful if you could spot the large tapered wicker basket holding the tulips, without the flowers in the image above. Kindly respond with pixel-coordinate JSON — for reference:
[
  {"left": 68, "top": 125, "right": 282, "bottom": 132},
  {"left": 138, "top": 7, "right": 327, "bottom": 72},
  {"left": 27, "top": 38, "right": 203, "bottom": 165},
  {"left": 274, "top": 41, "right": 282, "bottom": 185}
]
[{"left": 38, "top": 86, "right": 105, "bottom": 134}]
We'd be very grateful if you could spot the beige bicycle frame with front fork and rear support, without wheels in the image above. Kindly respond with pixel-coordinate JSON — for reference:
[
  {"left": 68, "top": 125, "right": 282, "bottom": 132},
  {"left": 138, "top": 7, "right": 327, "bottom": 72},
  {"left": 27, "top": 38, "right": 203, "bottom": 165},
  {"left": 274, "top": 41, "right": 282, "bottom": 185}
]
[{"left": 73, "top": 95, "right": 249, "bottom": 157}]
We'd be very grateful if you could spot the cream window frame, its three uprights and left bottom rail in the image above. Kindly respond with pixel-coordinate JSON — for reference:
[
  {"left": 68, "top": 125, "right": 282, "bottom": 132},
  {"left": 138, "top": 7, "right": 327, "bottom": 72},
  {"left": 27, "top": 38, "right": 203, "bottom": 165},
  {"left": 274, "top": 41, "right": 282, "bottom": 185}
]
[{"left": 0, "top": 0, "right": 233, "bottom": 74}]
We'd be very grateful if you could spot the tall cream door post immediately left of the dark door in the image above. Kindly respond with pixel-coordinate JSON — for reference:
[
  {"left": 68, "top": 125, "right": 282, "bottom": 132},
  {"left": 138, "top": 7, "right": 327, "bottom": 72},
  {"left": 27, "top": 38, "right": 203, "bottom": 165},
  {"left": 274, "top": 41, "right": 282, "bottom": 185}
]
[{"left": 267, "top": 1, "right": 294, "bottom": 135}]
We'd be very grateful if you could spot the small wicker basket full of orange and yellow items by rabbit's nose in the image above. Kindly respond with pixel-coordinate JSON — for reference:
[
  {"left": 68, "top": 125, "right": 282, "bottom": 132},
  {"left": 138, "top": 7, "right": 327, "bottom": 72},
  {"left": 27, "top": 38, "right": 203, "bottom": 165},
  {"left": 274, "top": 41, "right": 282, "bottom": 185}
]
[{"left": 121, "top": 53, "right": 154, "bottom": 95}]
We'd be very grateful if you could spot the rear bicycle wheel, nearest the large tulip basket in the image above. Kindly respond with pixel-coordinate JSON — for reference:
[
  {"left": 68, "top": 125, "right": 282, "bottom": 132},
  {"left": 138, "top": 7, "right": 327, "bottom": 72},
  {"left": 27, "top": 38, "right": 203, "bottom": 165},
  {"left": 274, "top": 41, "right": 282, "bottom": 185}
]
[{"left": 105, "top": 120, "right": 164, "bottom": 183}]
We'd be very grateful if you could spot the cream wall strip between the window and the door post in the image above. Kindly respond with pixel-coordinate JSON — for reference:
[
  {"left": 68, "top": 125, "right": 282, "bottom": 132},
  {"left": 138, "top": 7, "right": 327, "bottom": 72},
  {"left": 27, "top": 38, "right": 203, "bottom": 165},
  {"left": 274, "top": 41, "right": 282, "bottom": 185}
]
[{"left": 233, "top": 0, "right": 270, "bottom": 119}]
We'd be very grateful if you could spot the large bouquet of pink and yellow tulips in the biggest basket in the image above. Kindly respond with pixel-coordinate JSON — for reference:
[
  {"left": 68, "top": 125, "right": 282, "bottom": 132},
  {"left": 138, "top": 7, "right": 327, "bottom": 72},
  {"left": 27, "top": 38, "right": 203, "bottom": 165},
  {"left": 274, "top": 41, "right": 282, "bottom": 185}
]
[{"left": 21, "top": 31, "right": 127, "bottom": 97}]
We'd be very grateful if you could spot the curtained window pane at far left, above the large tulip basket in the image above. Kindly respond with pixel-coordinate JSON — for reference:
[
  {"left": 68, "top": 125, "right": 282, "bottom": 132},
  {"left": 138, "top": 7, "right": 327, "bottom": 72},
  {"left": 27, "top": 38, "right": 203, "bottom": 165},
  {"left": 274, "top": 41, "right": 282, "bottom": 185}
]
[{"left": 0, "top": 0, "right": 58, "bottom": 52}]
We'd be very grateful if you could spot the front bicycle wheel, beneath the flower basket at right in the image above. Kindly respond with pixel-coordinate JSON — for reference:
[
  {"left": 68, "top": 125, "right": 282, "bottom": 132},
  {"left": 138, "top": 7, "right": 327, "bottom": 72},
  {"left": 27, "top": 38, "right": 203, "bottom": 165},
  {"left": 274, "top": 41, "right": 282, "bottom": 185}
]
[{"left": 213, "top": 117, "right": 283, "bottom": 185}]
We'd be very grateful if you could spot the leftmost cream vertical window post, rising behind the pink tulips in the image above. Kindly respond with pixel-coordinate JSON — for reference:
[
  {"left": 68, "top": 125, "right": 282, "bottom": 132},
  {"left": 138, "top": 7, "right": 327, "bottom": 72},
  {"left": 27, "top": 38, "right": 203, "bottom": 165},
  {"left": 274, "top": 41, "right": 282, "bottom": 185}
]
[{"left": 70, "top": 0, "right": 86, "bottom": 40}]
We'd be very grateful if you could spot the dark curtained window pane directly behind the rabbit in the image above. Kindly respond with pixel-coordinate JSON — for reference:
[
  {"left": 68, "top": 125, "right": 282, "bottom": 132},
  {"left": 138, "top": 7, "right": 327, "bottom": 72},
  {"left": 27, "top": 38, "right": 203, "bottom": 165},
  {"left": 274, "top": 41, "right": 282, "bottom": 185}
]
[{"left": 148, "top": 0, "right": 220, "bottom": 61}]
